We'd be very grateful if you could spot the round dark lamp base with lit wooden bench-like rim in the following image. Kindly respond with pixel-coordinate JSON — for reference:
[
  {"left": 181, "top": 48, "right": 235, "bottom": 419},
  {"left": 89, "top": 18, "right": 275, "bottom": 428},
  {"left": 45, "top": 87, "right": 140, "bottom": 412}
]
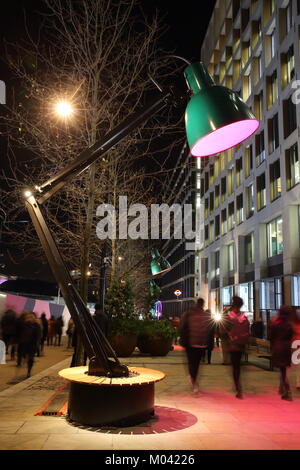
[{"left": 59, "top": 367, "right": 165, "bottom": 426}]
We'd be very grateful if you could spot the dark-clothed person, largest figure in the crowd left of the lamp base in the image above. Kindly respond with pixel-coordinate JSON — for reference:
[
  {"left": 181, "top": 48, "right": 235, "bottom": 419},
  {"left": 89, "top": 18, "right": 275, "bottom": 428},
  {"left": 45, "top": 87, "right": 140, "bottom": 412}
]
[{"left": 19, "top": 312, "right": 41, "bottom": 377}]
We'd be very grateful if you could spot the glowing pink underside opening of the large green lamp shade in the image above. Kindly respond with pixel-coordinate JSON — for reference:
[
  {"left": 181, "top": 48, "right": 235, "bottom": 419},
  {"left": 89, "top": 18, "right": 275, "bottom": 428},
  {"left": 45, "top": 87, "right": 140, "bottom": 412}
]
[{"left": 191, "top": 119, "right": 259, "bottom": 157}]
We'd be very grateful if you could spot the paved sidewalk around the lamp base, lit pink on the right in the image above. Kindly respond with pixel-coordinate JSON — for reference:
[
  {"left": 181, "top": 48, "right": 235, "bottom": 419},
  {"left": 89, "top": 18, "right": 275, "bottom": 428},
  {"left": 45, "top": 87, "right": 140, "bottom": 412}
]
[{"left": 0, "top": 350, "right": 300, "bottom": 451}]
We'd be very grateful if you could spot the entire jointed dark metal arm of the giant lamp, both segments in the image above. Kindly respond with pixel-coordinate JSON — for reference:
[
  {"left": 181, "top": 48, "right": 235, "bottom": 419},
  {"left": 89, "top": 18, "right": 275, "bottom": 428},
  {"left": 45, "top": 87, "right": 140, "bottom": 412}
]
[{"left": 25, "top": 88, "right": 184, "bottom": 377}]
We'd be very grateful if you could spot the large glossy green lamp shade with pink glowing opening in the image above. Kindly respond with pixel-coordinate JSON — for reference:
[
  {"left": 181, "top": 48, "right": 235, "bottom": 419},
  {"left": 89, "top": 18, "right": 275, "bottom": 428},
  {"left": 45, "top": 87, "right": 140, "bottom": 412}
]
[{"left": 184, "top": 62, "right": 259, "bottom": 157}]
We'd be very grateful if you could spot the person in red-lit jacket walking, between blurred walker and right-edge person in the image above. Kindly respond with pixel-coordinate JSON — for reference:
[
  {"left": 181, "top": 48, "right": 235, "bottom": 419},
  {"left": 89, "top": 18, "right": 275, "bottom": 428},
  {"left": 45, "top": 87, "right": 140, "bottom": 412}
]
[{"left": 228, "top": 296, "right": 250, "bottom": 398}]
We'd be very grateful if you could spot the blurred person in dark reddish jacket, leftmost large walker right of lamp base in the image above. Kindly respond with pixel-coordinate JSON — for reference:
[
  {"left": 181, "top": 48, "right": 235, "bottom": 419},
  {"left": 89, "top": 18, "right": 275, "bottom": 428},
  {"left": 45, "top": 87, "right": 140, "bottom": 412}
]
[{"left": 180, "top": 298, "right": 212, "bottom": 393}]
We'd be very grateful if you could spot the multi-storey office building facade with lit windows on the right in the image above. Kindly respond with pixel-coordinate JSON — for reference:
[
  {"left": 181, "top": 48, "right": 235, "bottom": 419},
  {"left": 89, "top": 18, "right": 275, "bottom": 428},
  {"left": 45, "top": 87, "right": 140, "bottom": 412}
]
[{"left": 197, "top": 0, "right": 300, "bottom": 336}]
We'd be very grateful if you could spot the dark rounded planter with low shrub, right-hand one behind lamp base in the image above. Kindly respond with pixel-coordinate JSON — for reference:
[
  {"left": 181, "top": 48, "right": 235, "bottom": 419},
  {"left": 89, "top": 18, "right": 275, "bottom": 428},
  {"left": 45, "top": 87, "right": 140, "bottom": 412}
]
[{"left": 138, "top": 320, "right": 175, "bottom": 356}]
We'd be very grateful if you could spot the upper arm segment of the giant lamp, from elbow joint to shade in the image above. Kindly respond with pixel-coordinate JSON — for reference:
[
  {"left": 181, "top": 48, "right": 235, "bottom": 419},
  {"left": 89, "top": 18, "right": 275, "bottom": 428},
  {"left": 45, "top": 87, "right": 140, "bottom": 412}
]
[{"left": 38, "top": 87, "right": 185, "bottom": 204}]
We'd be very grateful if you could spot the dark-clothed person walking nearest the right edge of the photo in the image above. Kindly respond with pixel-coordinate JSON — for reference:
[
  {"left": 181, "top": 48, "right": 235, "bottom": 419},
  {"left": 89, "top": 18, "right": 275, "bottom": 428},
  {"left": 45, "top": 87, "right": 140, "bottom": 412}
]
[{"left": 270, "top": 306, "right": 294, "bottom": 401}]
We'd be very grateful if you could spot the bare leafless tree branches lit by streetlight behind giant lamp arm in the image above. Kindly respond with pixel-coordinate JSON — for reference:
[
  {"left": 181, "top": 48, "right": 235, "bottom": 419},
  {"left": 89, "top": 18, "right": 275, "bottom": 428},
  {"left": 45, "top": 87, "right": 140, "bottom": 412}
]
[{"left": 1, "top": 0, "right": 185, "bottom": 304}]
